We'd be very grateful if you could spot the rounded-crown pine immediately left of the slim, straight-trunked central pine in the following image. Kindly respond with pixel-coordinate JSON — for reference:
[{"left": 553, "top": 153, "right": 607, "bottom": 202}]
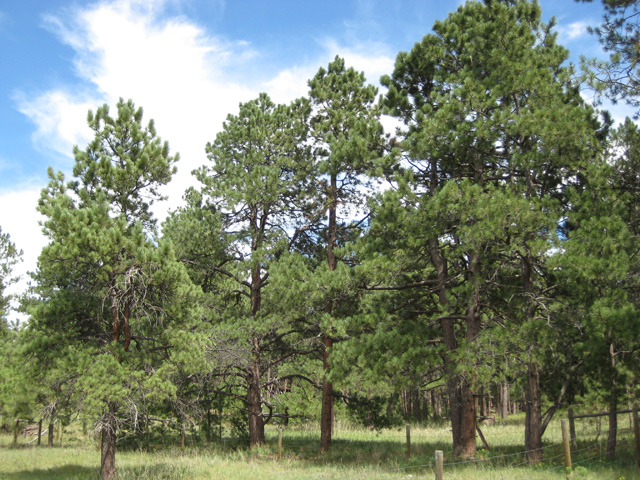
[{"left": 191, "top": 94, "right": 314, "bottom": 447}]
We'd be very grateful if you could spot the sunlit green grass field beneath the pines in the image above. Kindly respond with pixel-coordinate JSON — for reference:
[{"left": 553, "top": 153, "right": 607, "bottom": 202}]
[{"left": 0, "top": 417, "right": 640, "bottom": 480}]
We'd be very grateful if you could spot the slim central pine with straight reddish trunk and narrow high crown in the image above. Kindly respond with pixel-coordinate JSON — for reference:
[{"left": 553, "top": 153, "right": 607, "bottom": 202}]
[{"left": 309, "top": 57, "right": 383, "bottom": 451}]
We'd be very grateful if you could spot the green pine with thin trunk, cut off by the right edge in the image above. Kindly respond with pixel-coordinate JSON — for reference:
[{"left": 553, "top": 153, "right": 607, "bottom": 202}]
[{"left": 554, "top": 119, "right": 640, "bottom": 460}]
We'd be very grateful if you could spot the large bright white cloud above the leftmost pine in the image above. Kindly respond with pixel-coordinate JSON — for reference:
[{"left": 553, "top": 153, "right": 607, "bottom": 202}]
[{"left": 27, "top": 0, "right": 255, "bottom": 213}]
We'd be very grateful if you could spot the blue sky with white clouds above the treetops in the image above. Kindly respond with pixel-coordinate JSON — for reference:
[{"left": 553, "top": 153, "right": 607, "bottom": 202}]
[{"left": 0, "top": 0, "right": 626, "bottom": 318}]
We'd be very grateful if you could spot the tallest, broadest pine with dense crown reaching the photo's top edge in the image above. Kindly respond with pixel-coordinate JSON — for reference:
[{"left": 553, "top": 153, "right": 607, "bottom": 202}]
[{"left": 383, "top": 1, "right": 599, "bottom": 462}]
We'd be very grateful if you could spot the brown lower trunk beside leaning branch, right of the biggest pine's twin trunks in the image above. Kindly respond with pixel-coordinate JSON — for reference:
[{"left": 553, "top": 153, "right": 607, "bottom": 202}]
[{"left": 524, "top": 361, "right": 543, "bottom": 465}]
